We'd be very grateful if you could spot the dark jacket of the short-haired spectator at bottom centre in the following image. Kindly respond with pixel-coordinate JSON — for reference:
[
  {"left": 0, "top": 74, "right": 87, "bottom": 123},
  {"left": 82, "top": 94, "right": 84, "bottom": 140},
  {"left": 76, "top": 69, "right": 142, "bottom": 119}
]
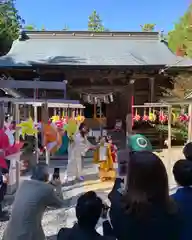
[{"left": 57, "top": 224, "right": 115, "bottom": 240}]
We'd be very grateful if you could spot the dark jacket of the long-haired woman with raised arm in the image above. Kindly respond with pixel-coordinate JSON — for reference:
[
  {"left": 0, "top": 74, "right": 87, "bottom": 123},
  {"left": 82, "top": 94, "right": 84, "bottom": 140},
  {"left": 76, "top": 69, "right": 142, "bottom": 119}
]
[{"left": 108, "top": 179, "right": 180, "bottom": 240}]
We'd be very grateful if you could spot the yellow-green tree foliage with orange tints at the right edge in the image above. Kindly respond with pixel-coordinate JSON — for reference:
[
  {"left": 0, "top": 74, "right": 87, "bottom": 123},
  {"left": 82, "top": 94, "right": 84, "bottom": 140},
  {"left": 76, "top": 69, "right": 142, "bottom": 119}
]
[{"left": 168, "top": 4, "right": 192, "bottom": 57}]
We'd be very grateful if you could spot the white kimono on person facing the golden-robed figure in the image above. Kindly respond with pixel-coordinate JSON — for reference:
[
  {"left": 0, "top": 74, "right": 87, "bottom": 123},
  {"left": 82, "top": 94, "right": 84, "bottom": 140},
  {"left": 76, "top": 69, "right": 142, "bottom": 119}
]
[{"left": 66, "top": 132, "right": 89, "bottom": 180}]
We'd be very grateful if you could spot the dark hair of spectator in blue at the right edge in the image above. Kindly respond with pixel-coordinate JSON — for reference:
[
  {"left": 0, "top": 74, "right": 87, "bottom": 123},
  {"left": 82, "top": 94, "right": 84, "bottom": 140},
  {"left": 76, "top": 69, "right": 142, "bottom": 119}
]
[{"left": 173, "top": 160, "right": 192, "bottom": 187}]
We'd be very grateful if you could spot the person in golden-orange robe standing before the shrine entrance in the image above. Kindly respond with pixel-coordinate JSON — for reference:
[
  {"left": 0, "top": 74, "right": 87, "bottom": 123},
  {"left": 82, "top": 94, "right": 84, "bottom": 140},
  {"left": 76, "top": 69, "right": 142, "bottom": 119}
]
[{"left": 93, "top": 136, "right": 115, "bottom": 181}]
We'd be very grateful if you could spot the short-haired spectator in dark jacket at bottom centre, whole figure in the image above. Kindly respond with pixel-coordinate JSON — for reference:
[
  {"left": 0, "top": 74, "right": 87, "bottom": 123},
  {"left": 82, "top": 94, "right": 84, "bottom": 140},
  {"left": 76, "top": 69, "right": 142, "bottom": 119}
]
[{"left": 57, "top": 191, "right": 115, "bottom": 240}]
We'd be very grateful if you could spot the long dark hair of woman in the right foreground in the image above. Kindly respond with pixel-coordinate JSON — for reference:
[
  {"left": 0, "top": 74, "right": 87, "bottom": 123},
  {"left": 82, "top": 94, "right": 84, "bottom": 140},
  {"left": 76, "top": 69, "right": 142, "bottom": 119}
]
[{"left": 123, "top": 151, "right": 175, "bottom": 219}]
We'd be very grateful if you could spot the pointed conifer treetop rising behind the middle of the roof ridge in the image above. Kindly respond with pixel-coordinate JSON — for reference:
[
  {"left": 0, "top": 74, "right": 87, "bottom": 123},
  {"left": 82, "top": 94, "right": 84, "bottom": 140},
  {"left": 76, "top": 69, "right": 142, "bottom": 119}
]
[{"left": 88, "top": 10, "right": 105, "bottom": 32}]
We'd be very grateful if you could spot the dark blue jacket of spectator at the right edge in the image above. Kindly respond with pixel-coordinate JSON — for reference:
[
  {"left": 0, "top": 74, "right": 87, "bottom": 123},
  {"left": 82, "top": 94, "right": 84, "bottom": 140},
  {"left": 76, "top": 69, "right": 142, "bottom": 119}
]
[{"left": 172, "top": 187, "right": 192, "bottom": 240}]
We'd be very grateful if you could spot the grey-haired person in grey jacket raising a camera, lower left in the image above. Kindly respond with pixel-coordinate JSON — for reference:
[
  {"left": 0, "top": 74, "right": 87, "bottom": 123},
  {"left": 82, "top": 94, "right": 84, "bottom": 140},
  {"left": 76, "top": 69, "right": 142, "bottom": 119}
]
[{"left": 3, "top": 163, "right": 64, "bottom": 240}]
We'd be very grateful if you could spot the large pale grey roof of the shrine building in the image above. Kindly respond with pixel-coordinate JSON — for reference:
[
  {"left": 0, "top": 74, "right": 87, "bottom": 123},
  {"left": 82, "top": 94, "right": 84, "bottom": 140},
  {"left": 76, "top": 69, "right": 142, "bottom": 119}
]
[{"left": 0, "top": 32, "right": 188, "bottom": 67}]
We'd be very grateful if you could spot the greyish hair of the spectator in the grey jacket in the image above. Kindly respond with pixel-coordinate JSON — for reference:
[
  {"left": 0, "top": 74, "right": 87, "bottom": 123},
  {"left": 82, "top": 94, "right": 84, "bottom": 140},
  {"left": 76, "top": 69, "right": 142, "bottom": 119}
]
[{"left": 31, "top": 163, "right": 49, "bottom": 182}]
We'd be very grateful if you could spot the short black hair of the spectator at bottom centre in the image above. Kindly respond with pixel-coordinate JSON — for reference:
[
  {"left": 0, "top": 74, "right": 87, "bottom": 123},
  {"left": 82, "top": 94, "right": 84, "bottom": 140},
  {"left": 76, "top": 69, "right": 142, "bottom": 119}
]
[{"left": 76, "top": 191, "right": 103, "bottom": 228}]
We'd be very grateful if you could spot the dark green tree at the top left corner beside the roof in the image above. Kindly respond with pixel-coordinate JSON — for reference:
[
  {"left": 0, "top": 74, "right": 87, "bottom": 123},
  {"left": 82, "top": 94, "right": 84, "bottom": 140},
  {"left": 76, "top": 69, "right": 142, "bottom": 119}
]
[{"left": 0, "top": 0, "right": 24, "bottom": 55}]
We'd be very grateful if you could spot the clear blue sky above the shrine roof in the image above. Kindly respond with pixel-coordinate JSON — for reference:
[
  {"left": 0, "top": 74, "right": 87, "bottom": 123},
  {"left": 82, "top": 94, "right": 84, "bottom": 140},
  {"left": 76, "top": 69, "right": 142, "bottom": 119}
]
[{"left": 16, "top": 0, "right": 190, "bottom": 32}]
